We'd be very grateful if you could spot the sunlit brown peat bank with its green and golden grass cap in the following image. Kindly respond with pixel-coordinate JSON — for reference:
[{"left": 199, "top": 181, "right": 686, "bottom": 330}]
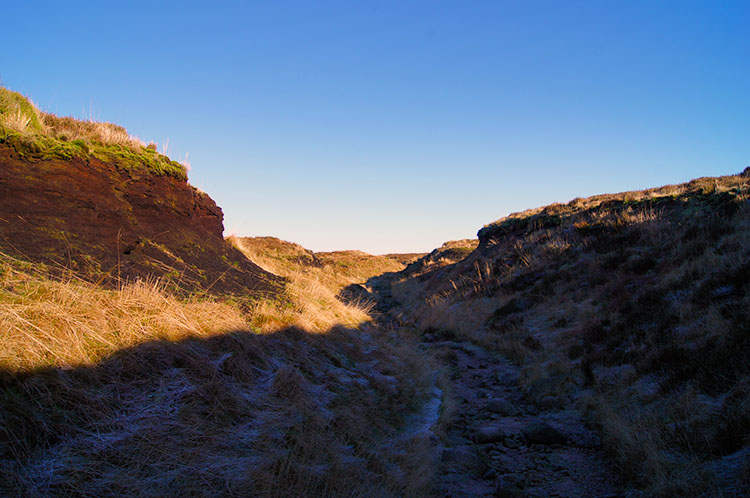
[{"left": 0, "top": 88, "right": 281, "bottom": 295}]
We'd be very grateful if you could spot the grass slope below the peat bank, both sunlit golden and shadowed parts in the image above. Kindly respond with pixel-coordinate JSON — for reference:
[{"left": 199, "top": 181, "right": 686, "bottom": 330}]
[{"left": 0, "top": 239, "right": 435, "bottom": 497}]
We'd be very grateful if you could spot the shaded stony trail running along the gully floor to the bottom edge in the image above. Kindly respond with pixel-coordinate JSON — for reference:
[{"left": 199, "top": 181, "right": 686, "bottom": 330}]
[{"left": 427, "top": 341, "right": 619, "bottom": 498}]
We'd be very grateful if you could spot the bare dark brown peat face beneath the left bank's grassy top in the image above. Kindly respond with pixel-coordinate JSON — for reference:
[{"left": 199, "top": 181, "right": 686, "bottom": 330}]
[{"left": 0, "top": 144, "right": 280, "bottom": 294}]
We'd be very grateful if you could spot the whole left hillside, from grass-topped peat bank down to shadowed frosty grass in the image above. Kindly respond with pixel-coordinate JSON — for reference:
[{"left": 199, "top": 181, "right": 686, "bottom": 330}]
[{"left": 0, "top": 88, "right": 435, "bottom": 497}]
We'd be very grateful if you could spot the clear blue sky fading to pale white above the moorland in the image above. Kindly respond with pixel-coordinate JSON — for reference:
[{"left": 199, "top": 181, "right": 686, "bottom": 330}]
[{"left": 0, "top": 0, "right": 750, "bottom": 253}]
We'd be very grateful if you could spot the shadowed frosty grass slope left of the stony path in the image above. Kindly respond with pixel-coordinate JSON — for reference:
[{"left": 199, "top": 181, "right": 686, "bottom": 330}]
[{"left": 0, "top": 327, "right": 432, "bottom": 496}]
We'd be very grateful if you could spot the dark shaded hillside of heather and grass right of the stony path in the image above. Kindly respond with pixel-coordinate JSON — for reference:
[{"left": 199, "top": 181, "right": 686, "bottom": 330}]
[{"left": 370, "top": 169, "right": 750, "bottom": 496}]
